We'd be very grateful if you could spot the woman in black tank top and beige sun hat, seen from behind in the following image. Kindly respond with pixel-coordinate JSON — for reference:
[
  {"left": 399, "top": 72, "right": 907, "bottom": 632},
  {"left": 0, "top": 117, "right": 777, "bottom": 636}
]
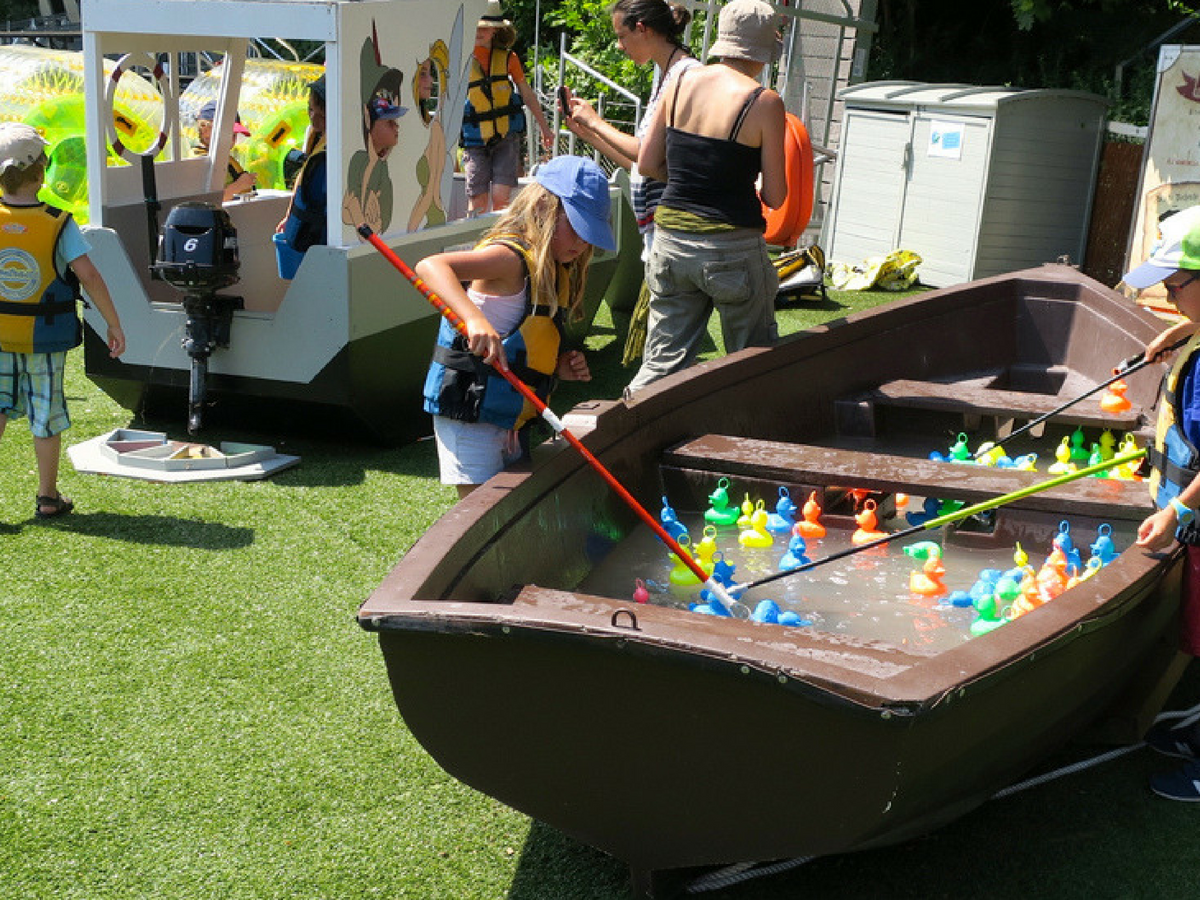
[{"left": 628, "top": 0, "right": 787, "bottom": 392}]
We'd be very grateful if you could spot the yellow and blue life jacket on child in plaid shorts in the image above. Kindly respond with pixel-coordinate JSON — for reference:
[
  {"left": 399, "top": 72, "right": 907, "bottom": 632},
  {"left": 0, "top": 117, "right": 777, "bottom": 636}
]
[{"left": 0, "top": 202, "right": 83, "bottom": 353}]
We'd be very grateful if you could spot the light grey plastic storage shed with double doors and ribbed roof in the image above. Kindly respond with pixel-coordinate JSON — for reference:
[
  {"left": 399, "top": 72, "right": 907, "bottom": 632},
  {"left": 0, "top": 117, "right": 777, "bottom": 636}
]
[{"left": 826, "top": 82, "right": 1106, "bottom": 287}]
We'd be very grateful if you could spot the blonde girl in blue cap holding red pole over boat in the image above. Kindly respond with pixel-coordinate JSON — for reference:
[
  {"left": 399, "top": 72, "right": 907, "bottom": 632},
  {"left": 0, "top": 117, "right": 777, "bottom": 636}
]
[{"left": 416, "top": 156, "right": 617, "bottom": 497}]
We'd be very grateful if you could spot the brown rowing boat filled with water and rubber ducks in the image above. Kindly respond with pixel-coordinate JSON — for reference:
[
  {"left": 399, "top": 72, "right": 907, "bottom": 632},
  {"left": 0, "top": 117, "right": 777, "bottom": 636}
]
[{"left": 359, "top": 266, "right": 1180, "bottom": 894}]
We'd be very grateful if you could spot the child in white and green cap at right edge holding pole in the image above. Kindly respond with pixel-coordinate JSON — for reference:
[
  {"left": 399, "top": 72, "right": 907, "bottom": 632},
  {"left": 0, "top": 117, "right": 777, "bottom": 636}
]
[{"left": 1122, "top": 206, "right": 1200, "bottom": 802}]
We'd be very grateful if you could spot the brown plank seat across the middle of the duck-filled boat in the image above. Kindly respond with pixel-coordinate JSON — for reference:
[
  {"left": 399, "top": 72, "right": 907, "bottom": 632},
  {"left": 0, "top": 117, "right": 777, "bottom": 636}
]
[{"left": 662, "top": 434, "right": 1153, "bottom": 522}]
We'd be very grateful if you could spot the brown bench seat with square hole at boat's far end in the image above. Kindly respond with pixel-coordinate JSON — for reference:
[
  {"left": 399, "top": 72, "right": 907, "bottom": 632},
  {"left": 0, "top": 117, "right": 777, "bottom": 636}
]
[{"left": 838, "top": 378, "right": 1142, "bottom": 438}]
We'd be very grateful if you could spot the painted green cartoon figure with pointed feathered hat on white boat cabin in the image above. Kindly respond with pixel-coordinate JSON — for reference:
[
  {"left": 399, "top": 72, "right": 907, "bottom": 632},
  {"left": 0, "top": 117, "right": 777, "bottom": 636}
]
[{"left": 342, "top": 22, "right": 408, "bottom": 233}]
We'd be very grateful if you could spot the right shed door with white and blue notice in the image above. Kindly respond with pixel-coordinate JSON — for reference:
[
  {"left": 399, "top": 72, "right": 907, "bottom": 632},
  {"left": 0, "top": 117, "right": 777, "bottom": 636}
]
[{"left": 896, "top": 112, "right": 992, "bottom": 287}]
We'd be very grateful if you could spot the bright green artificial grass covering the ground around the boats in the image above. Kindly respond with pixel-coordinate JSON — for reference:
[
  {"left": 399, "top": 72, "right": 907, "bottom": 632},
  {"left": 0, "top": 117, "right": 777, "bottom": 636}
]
[{"left": 7, "top": 294, "right": 1200, "bottom": 900}]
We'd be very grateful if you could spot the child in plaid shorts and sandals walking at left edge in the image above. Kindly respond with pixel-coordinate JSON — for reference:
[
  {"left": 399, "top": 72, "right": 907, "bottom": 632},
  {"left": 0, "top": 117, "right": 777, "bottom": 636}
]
[{"left": 0, "top": 122, "right": 125, "bottom": 518}]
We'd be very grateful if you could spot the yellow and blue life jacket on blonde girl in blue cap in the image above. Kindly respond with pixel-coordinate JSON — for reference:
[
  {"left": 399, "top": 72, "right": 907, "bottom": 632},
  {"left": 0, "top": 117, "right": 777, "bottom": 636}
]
[{"left": 425, "top": 235, "right": 570, "bottom": 428}]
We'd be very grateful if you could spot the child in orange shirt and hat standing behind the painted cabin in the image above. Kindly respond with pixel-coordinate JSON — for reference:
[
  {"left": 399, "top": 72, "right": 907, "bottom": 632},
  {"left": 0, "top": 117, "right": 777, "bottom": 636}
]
[{"left": 458, "top": 0, "right": 554, "bottom": 216}]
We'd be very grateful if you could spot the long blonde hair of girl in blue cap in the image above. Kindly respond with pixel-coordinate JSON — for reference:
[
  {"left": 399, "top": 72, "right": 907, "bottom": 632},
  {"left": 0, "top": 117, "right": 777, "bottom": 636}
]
[{"left": 486, "top": 181, "right": 592, "bottom": 322}]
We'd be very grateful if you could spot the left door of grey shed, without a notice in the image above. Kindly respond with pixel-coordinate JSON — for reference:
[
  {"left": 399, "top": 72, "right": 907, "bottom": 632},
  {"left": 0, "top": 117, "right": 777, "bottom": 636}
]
[{"left": 829, "top": 109, "right": 912, "bottom": 265}]
